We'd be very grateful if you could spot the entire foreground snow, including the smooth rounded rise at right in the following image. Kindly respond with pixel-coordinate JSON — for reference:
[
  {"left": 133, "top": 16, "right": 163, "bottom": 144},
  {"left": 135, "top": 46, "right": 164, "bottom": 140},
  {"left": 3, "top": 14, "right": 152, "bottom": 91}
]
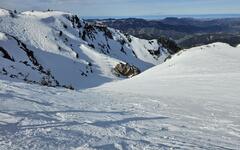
[{"left": 0, "top": 43, "right": 240, "bottom": 150}]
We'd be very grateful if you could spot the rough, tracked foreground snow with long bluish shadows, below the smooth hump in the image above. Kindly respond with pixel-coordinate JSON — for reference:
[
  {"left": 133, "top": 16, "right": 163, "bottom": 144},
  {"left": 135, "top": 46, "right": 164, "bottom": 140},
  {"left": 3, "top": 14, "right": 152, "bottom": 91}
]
[{"left": 0, "top": 81, "right": 240, "bottom": 149}]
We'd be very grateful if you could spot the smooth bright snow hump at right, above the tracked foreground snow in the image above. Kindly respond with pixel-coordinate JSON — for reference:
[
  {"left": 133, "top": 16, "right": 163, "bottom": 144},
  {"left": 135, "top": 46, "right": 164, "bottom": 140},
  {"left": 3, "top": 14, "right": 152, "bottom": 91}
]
[{"left": 99, "top": 43, "right": 240, "bottom": 99}]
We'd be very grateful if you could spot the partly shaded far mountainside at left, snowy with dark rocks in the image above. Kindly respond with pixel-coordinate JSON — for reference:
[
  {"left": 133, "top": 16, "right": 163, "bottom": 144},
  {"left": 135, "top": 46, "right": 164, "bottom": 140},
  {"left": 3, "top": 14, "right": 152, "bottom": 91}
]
[{"left": 0, "top": 9, "right": 169, "bottom": 88}]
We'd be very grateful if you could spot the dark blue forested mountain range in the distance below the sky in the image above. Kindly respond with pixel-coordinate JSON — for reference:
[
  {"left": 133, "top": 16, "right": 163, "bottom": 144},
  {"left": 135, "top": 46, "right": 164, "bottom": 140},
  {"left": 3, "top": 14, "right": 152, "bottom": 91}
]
[{"left": 88, "top": 17, "right": 240, "bottom": 48}]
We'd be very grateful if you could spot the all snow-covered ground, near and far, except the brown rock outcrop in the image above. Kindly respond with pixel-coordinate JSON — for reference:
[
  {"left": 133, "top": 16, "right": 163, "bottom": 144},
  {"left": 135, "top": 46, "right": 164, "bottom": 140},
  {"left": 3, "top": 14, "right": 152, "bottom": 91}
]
[{"left": 0, "top": 9, "right": 240, "bottom": 150}]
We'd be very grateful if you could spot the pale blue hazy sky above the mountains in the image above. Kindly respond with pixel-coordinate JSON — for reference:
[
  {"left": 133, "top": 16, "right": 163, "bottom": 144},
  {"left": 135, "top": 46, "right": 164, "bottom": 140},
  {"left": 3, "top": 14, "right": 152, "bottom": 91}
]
[{"left": 0, "top": 0, "right": 240, "bottom": 16}]
